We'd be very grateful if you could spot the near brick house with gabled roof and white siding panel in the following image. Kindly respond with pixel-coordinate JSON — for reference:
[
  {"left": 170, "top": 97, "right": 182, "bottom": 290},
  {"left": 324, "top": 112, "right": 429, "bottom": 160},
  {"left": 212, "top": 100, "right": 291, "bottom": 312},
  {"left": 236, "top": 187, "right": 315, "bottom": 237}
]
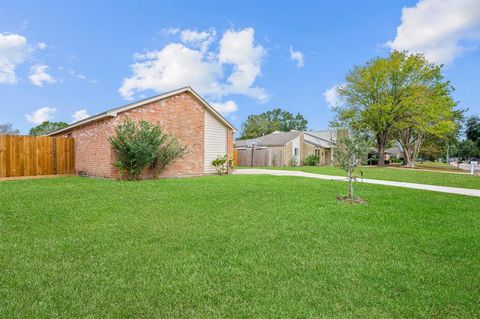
[{"left": 49, "top": 87, "right": 235, "bottom": 178}]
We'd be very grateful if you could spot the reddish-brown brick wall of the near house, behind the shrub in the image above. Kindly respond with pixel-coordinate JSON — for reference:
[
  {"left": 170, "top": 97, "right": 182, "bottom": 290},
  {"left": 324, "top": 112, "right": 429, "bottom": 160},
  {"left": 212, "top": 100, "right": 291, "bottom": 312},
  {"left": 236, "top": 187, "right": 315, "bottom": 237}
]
[{"left": 53, "top": 92, "right": 227, "bottom": 178}]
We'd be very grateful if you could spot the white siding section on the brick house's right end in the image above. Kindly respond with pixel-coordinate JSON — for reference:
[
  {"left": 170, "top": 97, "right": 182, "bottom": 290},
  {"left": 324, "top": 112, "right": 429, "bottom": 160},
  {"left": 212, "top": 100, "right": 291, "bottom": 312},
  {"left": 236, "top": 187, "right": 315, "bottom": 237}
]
[{"left": 204, "top": 110, "right": 227, "bottom": 174}]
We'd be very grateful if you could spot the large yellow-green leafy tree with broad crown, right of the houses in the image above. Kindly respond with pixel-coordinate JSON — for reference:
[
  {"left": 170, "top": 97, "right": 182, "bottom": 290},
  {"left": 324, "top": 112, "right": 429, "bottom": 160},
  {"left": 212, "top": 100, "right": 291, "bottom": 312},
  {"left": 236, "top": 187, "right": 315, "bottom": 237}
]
[{"left": 335, "top": 51, "right": 455, "bottom": 166}]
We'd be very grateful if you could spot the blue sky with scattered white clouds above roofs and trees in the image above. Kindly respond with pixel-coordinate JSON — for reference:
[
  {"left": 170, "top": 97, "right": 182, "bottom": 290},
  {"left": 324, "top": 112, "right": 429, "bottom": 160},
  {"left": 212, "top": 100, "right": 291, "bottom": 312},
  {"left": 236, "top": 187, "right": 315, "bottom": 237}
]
[{"left": 0, "top": 0, "right": 480, "bottom": 133}]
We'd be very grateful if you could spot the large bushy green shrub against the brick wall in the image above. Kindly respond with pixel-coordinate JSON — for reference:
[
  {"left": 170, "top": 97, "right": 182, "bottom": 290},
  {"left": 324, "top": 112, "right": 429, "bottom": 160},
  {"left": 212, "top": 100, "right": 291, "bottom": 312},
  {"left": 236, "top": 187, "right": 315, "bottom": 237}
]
[{"left": 109, "top": 119, "right": 185, "bottom": 180}]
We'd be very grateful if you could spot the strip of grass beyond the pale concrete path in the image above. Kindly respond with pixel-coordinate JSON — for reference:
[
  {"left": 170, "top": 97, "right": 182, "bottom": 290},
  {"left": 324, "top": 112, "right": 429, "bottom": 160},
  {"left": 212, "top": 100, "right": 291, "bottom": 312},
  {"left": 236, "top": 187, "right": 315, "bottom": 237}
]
[{"left": 239, "top": 165, "right": 480, "bottom": 189}]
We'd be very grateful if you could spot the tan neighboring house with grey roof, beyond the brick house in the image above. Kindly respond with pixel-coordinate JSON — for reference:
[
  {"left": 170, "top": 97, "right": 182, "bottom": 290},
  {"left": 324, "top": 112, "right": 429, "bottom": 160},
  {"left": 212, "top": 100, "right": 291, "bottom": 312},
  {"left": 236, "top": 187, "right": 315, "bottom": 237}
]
[{"left": 235, "top": 130, "right": 335, "bottom": 166}]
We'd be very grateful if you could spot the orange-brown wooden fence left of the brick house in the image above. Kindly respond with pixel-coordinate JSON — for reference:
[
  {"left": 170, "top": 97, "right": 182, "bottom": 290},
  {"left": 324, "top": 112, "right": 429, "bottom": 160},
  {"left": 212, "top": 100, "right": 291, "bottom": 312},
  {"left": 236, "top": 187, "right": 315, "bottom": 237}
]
[{"left": 0, "top": 135, "right": 75, "bottom": 177}]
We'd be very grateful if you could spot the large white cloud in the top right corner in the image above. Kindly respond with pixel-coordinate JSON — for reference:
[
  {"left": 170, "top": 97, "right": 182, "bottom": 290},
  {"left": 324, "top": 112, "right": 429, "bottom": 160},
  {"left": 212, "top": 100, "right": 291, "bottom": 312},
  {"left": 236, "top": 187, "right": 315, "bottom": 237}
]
[{"left": 386, "top": 0, "right": 480, "bottom": 64}]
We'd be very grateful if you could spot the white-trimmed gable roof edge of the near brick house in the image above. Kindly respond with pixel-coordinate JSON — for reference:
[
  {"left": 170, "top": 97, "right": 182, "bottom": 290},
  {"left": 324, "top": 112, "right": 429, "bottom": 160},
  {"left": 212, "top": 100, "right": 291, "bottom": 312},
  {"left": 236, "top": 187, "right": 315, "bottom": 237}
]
[{"left": 47, "top": 86, "right": 237, "bottom": 136}]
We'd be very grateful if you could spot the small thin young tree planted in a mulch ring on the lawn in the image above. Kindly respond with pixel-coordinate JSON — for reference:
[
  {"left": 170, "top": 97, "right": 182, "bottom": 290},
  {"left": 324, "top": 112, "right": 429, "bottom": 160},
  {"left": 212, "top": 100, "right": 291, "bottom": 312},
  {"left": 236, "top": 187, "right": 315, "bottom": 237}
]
[{"left": 335, "top": 133, "right": 369, "bottom": 202}]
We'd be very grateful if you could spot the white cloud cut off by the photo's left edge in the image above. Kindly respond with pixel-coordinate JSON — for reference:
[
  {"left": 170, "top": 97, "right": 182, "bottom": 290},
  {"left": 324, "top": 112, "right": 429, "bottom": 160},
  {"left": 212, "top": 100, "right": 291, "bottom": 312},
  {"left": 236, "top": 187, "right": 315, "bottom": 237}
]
[{"left": 0, "top": 33, "right": 30, "bottom": 84}]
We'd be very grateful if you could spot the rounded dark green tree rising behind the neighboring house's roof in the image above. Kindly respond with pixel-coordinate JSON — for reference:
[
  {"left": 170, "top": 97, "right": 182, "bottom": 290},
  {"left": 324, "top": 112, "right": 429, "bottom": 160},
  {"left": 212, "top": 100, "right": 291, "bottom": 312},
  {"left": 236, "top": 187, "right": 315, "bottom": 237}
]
[{"left": 240, "top": 108, "right": 308, "bottom": 139}]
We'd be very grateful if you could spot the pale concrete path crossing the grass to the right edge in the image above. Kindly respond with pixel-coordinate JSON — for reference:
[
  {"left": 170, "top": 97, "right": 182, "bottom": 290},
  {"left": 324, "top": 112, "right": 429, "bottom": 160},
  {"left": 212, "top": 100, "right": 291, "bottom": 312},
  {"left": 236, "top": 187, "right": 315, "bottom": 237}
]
[{"left": 234, "top": 168, "right": 480, "bottom": 197}]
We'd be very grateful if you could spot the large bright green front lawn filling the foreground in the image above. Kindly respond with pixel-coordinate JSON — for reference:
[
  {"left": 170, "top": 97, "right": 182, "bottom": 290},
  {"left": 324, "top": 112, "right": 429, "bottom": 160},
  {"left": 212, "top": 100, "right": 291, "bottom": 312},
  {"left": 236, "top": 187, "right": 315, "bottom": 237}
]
[{"left": 0, "top": 176, "right": 480, "bottom": 318}]
